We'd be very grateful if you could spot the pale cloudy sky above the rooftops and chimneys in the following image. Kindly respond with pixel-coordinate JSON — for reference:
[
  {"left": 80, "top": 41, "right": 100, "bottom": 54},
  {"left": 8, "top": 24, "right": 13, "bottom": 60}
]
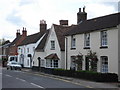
[{"left": 0, "top": 0, "right": 120, "bottom": 41}]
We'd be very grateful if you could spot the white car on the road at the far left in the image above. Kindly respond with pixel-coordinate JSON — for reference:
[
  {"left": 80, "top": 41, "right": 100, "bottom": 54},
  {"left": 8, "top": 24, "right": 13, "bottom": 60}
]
[{"left": 7, "top": 61, "right": 22, "bottom": 70}]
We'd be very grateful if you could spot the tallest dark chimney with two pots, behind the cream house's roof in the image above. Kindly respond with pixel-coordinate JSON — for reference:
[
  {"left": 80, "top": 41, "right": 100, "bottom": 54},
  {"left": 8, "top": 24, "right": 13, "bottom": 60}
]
[{"left": 77, "top": 6, "right": 87, "bottom": 24}]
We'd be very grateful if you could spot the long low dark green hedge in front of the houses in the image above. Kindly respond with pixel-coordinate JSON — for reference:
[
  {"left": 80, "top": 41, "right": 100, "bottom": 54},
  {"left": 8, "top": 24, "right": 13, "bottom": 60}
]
[{"left": 32, "top": 67, "right": 118, "bottom": 82}]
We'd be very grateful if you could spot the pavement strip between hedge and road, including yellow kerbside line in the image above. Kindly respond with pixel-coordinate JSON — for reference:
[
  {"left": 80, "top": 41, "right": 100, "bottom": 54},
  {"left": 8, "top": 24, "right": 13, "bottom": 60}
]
[{"left": 22, "top": 68, "right": 120, "bottom": 90}]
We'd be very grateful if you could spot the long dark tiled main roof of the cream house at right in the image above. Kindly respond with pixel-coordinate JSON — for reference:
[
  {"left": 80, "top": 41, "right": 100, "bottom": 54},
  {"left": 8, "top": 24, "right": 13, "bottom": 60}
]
[{"left": 65, "top": 13, "right": 120, "bottom": 36}]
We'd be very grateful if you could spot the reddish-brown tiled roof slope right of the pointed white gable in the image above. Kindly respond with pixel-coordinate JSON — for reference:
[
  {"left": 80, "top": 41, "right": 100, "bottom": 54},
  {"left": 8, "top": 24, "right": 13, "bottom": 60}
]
[{"left": 54, "top": 24, "right": 75, "bottom": 51}]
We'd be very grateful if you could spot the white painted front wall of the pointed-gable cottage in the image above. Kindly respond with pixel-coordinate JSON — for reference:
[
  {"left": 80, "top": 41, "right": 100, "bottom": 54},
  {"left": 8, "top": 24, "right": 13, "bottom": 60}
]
[{"left": 34, "top": 25, "right": 65, "bottom": 68}]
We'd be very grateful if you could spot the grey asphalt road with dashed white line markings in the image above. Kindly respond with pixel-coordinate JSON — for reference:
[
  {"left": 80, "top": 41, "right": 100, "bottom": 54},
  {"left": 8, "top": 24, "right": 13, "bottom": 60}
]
[{"left": 0, "top": 68, "right": 94, "bottom": 90}]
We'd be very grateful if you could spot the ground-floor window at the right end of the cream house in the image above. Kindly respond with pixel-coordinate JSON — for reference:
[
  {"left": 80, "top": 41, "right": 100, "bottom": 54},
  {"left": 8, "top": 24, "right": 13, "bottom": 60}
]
[{"left": 101, "top": 56, "right": 108, "bottom": 73}]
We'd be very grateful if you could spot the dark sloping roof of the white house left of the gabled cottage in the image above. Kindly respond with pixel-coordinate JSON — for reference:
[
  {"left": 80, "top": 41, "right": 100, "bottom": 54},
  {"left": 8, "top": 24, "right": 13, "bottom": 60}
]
[{"left": 19, "top": 32, "right": 43, "bottom": 46}]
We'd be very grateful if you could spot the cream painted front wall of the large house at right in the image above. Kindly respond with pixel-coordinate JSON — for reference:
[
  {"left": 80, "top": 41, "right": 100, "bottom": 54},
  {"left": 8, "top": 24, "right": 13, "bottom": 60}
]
[{"left": 65, "top": 28, "right": 118, "bottom": 74}]
